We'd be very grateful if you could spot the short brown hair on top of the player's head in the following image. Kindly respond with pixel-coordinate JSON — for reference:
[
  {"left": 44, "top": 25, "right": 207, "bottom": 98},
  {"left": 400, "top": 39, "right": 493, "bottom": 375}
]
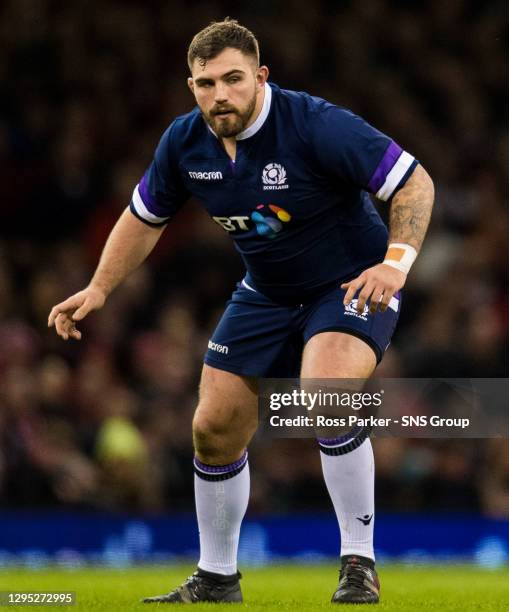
[{"left": 187, "top": 17, "right": 260, "bottom": 69}]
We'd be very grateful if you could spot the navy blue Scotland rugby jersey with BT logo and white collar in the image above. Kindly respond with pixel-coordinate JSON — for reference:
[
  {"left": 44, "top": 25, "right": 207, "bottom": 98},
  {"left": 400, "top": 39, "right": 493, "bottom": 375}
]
[{"left": 130, "top": 84, "right": 417, "bottom": 304}]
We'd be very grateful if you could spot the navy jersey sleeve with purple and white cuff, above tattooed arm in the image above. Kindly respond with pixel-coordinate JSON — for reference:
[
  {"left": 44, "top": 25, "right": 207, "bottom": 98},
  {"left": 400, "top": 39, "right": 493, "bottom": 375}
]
[{"left": 311, "top": 105, "right": 418, "bottom": 201}]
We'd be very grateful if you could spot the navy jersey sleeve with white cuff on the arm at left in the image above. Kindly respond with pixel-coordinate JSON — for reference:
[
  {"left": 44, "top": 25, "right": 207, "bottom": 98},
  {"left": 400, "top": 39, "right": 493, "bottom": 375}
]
[{"left": 130, "top": 123, "right": 189, "bottom": 226}]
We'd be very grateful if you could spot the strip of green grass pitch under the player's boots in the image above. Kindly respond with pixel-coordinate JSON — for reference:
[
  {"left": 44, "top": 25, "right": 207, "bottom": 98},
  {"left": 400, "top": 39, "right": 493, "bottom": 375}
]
[{"left": 0, "top": 565, "right": 509, "bottom": 612}]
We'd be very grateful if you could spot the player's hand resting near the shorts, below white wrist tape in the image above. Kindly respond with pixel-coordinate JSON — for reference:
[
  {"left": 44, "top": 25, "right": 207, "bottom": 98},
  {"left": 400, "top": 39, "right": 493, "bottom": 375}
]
[{"left": 341, "top": 263, "right": 407, "bottom": 314}]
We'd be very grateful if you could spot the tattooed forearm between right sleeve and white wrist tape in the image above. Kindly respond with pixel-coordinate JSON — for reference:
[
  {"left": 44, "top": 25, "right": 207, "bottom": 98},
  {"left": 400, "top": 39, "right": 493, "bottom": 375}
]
[{"left": 389, "top": 165, "right": 435, "bottom": 252}]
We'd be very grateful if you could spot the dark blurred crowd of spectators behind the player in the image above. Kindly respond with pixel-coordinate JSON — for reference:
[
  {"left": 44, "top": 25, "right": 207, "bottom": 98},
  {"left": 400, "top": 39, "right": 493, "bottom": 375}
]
[{"left": 0, "top": 0, "right": 509, "bottom": 517}]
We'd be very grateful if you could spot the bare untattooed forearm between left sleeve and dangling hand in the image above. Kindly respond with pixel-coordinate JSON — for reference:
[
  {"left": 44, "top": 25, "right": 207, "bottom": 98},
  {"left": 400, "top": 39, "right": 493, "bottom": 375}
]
[{"left": 90, "top": 209, "right": 164, "bottom": 297}]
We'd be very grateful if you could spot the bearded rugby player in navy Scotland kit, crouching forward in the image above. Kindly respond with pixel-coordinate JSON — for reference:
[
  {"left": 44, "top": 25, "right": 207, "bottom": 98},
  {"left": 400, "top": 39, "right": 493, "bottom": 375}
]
[{"left": 49, "top": 19, "right": 433, "bottom": 603}]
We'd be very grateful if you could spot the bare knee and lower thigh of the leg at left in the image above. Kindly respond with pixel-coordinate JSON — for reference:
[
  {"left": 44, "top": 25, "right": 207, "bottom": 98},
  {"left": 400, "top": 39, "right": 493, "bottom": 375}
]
[{"left": 193, "top": 364, "right": 258, "bottom": 450}]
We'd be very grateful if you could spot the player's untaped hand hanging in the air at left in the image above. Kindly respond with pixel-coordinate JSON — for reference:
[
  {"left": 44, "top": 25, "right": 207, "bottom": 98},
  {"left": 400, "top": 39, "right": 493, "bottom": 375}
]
[{"left": 48, "top": 287, "right": 106, "bottom": 340}]
